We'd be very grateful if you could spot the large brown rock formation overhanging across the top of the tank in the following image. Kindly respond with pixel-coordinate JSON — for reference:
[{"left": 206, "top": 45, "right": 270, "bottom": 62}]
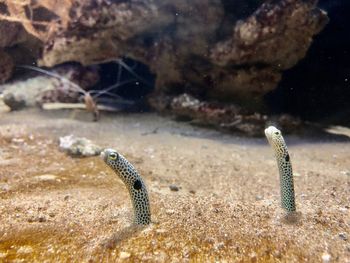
[{"left": 0, "top": 0, "right": 327, "bottom": 109}]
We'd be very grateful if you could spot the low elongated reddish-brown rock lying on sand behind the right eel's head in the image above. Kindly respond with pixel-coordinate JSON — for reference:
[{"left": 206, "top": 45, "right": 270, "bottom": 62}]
[{"left": 150, "top": 93, "right": 303, "bottom": 136}]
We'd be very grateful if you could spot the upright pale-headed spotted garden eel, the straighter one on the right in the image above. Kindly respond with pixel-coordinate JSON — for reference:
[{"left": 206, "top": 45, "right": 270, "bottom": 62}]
[{"left": 265, "top": 126, "right": 296, "bottom": 214}]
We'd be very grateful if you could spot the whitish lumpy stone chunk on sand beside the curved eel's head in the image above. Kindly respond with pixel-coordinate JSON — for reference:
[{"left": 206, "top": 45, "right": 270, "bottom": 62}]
[{"left": 60, "top": 135, "right": 102, "bottom": 157}]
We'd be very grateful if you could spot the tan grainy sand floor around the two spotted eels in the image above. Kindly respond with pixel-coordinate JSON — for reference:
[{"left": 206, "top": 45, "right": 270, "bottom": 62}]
[{"left": 0, "top": 110, "right": 350, "bottom": 262}]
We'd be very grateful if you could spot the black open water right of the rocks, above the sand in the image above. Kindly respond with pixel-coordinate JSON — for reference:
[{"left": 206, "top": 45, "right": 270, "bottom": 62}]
[{"left": 266, "top": 0, "right": 350, "bottom": 121}]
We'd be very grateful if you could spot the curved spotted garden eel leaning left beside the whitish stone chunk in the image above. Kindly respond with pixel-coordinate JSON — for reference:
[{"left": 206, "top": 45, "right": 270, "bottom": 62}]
[{"left": 101, "top": 149, "right": 151, "bottom": 225}]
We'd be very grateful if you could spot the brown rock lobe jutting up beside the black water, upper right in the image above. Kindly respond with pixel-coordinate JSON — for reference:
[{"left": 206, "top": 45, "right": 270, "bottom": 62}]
[{"left": 211, "top": 0, "right": 328, "bottom": 71}]
